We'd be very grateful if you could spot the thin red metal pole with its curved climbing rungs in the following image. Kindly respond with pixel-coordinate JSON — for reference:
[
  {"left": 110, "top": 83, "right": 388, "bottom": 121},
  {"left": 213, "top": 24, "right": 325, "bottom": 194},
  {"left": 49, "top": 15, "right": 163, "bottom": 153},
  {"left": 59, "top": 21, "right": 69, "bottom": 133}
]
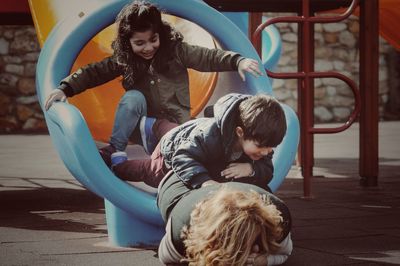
[{"left": 252, "top": 0, "right": 360, "bottom": 197}]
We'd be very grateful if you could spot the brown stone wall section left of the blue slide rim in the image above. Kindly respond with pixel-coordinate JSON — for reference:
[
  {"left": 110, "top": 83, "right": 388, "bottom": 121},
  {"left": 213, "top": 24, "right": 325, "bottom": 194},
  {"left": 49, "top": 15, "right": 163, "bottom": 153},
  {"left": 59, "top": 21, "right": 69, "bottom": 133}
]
[{"left": 0, "top": 26, "right": 47, "bottom": 133}]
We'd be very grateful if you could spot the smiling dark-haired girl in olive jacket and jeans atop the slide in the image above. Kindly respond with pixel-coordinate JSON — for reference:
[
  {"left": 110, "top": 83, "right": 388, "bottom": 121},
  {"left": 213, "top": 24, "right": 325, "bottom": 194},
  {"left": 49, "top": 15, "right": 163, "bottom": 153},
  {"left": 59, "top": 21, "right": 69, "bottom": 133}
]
[{"left": 45, "top": 1, "right": 262, "bottom": 166}]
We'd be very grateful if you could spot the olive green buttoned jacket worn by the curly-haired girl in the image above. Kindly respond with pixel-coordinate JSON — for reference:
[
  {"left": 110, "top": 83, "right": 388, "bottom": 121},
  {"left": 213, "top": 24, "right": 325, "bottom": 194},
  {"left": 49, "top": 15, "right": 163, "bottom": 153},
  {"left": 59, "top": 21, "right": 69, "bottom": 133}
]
[{"left": 60, "top": 41, "right": 243, "bottom": 124}]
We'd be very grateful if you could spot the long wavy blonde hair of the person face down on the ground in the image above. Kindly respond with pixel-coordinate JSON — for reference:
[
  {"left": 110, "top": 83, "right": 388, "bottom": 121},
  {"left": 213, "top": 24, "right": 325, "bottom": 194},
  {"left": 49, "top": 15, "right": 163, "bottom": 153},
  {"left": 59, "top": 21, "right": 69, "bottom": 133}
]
[{"left": 181, "top": 186, "right": 282, "bottom": 266}]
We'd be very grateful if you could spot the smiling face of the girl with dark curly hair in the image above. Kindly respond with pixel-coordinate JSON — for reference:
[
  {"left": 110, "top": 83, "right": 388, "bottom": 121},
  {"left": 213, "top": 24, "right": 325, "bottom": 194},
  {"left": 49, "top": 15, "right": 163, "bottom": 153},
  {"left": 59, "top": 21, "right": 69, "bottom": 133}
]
[{"left": 129, "top": 30, "right": 160, "bottom": 60}]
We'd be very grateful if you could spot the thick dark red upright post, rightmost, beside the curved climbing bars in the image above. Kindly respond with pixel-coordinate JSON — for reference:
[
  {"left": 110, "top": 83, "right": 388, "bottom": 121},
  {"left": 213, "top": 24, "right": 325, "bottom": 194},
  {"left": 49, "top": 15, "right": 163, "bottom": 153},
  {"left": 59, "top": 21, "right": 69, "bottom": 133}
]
[{"left": 359, "top": 0, "right": 379, "bottom": 187}]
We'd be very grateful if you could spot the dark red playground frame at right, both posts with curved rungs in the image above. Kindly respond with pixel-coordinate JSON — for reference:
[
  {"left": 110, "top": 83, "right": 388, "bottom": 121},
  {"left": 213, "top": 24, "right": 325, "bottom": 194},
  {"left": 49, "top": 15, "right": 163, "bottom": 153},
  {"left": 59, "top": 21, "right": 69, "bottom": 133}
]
[{"left": 241, "top": 0, "right": 382, "bottom": 197}]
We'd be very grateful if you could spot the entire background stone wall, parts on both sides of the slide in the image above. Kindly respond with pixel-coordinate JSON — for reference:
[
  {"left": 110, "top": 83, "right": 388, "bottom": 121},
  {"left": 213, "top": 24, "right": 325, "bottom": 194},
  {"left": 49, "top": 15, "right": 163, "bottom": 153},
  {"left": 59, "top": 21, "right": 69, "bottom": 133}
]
[{"left": 0, "top": 13, "right": 400, "bottom": 134}]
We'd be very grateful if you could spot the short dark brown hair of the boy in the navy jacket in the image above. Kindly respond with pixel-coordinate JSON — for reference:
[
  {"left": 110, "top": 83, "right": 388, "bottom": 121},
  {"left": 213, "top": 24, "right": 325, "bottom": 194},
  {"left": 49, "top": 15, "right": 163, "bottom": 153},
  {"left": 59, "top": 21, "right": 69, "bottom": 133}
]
[{"left": 237, "top": 94, "right": 286, "bottom": 147}]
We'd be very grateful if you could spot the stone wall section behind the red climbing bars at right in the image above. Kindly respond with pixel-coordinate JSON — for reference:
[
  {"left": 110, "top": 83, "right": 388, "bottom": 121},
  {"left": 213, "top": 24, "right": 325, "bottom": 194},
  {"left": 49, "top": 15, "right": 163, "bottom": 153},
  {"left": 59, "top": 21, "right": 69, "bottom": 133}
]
[{"left": 267, "top": 13, "right": 400, "bottom": 123}]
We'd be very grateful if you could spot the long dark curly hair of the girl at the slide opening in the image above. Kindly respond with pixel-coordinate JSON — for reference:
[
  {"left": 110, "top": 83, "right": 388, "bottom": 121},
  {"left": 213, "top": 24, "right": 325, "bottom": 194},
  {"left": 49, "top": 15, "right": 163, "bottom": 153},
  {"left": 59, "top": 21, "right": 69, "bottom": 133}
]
[{"left": 112, "top": 1, "right": 183, "bottom": 84}]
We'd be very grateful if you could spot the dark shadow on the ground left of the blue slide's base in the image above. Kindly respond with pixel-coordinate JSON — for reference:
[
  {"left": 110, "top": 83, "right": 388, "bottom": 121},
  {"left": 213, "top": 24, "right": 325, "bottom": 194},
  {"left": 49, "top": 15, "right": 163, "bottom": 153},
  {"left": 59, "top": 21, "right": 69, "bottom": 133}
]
[{"left": 0, "top": 188, "right": 107, "bottom": 234}]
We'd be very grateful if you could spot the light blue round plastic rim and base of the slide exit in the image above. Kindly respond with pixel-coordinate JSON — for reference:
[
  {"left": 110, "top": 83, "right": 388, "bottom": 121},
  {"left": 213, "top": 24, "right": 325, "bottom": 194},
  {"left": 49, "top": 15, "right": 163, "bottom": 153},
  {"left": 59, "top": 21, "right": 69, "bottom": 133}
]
[{"left": 33, "top": 0, "right": 299, "bottom": 246}]
